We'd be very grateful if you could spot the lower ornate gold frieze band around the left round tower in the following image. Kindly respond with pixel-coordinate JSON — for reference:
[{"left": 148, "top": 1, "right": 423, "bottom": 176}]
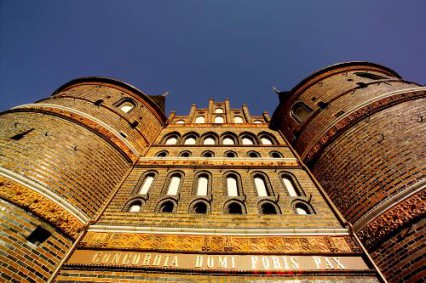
[{"left": 0, "top": 176, "right": 84, "bottom": 239}]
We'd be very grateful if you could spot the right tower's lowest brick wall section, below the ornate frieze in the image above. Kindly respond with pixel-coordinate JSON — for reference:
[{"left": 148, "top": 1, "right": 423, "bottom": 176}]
[{"left": 372, "top": 218, "right": 426, "bottom": 283}]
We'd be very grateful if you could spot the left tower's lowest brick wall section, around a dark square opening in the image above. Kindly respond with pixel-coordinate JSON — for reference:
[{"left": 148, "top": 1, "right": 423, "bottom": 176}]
[{"left": 0, "top": 199, "right": 72, "bottom": 283}]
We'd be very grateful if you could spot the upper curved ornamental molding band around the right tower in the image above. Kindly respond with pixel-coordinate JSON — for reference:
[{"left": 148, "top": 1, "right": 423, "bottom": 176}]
[{"left": 302, "top": 87, "right": 426, "bottom": 164}]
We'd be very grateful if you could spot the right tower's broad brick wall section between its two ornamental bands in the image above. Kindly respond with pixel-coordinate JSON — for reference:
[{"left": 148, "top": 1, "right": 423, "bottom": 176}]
[{"left": 312, "top": 99, "right": 426, "bottom": 223}]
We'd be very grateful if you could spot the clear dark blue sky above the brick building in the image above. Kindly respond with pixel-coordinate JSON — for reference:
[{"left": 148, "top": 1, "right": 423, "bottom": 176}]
[{"left": 0, "top": 0, "right": 426, "bottom": 114}]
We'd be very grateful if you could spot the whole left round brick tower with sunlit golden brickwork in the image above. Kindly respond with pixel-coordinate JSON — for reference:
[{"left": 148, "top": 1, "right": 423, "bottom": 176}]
[{"left": 0, "top": 78, "right": 166, "bottom": 282}]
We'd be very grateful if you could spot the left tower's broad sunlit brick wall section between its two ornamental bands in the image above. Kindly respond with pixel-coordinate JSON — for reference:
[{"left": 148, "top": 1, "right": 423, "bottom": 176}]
[{"left": 0, "top": 112, "right": 130, "bottom": 216}]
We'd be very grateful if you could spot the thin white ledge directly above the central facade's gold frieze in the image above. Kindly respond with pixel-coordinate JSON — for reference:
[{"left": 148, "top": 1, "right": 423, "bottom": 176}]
[{"left": 88, "top": 225, "right": 349, "bottom": 236}]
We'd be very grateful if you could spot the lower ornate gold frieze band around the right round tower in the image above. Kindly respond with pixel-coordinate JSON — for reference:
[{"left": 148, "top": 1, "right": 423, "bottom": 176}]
[{"left": 358, "top": 191, "right": 426, "bottom": 248}]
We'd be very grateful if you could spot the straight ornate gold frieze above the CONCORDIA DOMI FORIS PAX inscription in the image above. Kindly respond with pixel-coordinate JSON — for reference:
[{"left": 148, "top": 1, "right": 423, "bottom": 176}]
[{"left": 79, "top": 232, "right": 361, "bottom": 254}]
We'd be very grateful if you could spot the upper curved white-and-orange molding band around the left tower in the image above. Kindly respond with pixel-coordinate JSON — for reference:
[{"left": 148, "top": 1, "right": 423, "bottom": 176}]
[{"left": 11, "top": 103, "right": 141, "bottom": 162}]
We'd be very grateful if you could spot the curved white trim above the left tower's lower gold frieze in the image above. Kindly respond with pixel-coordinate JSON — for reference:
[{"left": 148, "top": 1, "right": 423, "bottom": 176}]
[{"left": 0, "top": 166, "right": 89, "bottom": 223}]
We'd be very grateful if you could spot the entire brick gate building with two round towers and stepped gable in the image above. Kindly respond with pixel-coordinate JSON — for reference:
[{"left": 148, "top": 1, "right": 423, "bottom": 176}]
[{"left": 0, "top": 63, "right": 425, "bottom": 282}]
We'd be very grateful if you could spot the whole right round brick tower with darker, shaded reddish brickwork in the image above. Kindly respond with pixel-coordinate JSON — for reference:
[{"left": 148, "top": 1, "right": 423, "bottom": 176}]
[{"left": 271, "top": 62, "right": 426, "bottom": 282}]
